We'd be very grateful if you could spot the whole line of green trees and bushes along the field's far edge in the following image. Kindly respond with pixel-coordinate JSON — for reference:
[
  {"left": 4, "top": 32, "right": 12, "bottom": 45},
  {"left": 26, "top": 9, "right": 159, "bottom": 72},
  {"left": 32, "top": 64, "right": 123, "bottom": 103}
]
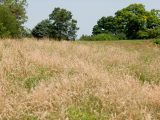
[{"left": 0, "top": 0, "right": 160, "bottom": 40}]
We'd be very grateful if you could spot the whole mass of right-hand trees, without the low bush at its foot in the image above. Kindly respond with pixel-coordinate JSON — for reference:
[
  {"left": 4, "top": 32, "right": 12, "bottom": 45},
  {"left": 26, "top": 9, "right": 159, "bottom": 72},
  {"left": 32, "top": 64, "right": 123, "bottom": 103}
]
[{"left": 93, "top": 4, "right": 160, "bottom": 39}]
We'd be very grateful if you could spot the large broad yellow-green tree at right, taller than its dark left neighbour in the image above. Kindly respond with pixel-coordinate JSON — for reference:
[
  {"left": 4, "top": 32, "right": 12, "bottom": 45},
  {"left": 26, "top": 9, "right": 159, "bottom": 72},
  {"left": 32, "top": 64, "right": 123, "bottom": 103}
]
[{"left": 116, "top": 4, "right": 160, "bottom": 39}]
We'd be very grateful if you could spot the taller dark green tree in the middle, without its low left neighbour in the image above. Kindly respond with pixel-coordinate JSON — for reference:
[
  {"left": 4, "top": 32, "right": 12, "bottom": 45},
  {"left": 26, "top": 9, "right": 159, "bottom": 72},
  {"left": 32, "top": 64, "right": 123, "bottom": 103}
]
[{"left": 49, "top": 8, "right": 79, "bottom": 40}]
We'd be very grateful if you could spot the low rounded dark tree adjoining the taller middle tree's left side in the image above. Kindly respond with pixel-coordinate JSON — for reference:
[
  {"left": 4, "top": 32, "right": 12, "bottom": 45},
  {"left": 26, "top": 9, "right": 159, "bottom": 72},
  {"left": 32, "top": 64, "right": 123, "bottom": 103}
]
[{"left": 32, "top": 19, "right": 51, "bottom": 39}]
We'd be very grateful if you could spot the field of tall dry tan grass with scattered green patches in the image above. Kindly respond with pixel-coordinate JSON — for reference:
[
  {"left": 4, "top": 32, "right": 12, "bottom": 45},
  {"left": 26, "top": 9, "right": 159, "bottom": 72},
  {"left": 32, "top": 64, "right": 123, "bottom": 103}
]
[{"left": 0, "top": 39, "right": 160, "bottom": 120}]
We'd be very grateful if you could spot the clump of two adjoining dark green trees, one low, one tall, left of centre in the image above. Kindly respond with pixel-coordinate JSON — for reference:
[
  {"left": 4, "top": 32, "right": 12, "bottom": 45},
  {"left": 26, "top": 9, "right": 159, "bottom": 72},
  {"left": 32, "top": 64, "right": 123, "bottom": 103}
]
[{"left": 32, "top": 8, "right": 79, "bottom": 40}]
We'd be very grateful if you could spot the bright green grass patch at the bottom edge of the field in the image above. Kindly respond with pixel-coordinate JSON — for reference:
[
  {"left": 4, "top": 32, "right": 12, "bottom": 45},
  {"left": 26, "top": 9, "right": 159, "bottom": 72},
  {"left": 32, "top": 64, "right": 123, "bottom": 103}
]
[{"left": 67, "top": 96, "right": 108, "bottom": 120}]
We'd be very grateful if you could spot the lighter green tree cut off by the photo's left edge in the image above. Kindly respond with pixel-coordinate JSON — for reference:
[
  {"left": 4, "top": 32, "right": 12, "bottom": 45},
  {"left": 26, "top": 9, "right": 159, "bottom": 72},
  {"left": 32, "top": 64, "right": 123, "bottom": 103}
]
[{"left": 0, "top": 0, "right": 27, "bottom": 38}]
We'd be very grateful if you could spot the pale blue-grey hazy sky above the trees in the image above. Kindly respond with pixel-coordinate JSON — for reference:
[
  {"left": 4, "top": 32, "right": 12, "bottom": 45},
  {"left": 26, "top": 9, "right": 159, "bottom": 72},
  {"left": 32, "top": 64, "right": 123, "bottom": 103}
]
[{"left": 25, "top": 0, "right": 160, "bottom": 37}]
